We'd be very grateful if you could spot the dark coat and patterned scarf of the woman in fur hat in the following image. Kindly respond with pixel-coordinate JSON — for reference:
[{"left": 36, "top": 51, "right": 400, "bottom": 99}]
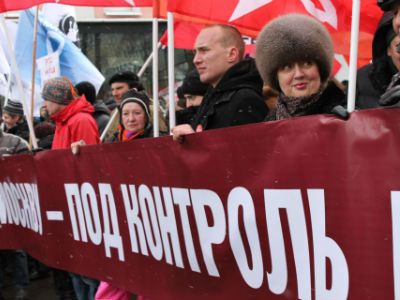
[{"left": 265, "top": 81, "right": 346, "bottom": 121}]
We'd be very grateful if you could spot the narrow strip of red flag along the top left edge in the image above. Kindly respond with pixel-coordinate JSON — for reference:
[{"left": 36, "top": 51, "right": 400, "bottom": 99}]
[{"left": 0, "top": 0, "right": 153, "bottom": 12}]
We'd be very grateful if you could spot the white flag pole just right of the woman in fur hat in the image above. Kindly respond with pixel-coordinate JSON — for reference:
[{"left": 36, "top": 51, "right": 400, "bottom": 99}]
[{"left": 347, "top": 0, "right": 360, "bottom": 112}]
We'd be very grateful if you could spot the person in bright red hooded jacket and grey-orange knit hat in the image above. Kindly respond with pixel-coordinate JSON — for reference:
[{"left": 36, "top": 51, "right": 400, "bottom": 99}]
[{"left": 42, "top": 77, "right": 100, "bottom": 149}]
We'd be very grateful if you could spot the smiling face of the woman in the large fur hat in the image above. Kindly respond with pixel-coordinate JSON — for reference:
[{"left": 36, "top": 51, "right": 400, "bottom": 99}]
[{"left": 278, "top": 61, "right": 321, "bottom": 97}]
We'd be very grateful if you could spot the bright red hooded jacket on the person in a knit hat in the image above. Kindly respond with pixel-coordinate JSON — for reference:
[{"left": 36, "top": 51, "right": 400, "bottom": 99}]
[{"left": 51, "top": 96, "right": 100, "bottom": 149}]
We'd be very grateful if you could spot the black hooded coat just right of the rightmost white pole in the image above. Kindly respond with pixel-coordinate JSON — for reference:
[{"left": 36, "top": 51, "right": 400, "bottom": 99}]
[{"left": 356, "top": 13, "right": 398, "bottom": 109}]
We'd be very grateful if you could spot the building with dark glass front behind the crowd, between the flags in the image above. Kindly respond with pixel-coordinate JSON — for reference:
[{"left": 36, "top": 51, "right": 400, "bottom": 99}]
[{"left": 7, "top": 7, "right": 193, "bottom": 98}]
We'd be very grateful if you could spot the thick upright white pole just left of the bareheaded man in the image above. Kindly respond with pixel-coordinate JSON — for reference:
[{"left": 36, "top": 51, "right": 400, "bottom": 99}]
[{"left": 167, "top": 12, "right": 176, "bottom": 131}]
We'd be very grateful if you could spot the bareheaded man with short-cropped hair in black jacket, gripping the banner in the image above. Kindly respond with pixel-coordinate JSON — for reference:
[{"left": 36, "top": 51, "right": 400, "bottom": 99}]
[{"left": 172, "top": 25, "right": 268, "bottom": 142}]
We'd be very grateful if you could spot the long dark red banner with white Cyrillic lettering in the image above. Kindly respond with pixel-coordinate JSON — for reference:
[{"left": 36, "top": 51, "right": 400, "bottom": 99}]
[{"left": 0, "top": 109, "right": 400, "bottom": 299}]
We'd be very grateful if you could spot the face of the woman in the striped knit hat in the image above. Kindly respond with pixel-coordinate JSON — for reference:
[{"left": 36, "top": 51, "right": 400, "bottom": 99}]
[{"left": 122, "top": 102, "right": 146, "bottom": 132}]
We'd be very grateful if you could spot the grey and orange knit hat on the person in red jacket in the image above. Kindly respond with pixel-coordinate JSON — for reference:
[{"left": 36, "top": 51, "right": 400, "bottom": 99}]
[{"left": 42, "top": 77, "right": 78, "bottom": 105}]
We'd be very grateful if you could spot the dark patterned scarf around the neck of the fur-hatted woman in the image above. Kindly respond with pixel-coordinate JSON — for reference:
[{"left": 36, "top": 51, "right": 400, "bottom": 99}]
[{"left": 276, "top": 90, "right": 322, "bottom": 120}]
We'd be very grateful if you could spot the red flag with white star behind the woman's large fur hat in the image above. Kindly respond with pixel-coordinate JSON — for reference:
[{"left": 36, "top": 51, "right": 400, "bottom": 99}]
[{"left": 168, "top": 0, "right": 382, "bottom": 65}]
